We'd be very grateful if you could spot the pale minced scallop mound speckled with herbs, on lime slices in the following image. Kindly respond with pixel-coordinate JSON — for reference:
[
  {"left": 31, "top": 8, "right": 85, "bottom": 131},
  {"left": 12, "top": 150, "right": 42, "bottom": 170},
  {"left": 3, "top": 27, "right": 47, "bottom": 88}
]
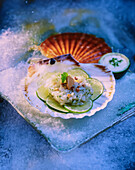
[{"left": 49, "top": 77, "right": 93, "bottom": 105}]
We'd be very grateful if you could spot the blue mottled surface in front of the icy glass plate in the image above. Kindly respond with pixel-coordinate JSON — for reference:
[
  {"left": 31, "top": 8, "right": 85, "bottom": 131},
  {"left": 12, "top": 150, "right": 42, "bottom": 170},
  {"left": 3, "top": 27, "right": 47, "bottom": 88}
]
[{"left": 0, "top": 98, "right": 135, "bottom": 170}]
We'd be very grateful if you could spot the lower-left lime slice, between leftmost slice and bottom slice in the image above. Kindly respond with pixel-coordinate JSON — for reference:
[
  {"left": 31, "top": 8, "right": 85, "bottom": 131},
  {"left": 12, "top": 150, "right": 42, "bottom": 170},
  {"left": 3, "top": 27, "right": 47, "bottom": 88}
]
[{"left": 46, "top": 95, "right": 69, "bottom": 113}]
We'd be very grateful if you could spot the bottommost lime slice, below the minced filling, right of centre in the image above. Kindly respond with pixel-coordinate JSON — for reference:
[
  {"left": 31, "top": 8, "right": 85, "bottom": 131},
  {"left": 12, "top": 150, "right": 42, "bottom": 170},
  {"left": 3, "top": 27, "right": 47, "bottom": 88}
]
[{"left": 64, "top": 100, "right": 93, "bottom": 113}]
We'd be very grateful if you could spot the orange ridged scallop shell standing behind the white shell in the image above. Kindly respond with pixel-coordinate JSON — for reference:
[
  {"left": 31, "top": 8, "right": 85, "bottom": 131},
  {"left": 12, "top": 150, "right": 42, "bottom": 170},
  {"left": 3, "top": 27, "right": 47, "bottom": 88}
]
[{"left": 40, "top": 33, "right": 112, "bottom": 63}]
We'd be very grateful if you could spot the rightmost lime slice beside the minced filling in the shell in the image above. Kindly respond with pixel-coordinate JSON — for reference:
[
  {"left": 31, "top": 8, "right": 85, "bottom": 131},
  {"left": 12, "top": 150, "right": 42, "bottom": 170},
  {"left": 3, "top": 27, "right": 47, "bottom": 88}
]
[{"left": 87, "top": 78, "right": 104, "bottom": 100}]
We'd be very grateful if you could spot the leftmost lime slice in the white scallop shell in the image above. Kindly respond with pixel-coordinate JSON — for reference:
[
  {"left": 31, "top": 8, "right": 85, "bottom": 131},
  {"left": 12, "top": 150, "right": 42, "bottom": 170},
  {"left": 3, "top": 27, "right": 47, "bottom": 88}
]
[{"left": 36, "top": 86, "right": 49, "bottom": 102}]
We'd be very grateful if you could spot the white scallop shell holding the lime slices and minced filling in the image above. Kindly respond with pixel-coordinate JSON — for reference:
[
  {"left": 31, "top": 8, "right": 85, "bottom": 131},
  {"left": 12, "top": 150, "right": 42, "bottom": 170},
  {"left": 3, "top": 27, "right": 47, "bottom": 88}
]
[{"left": 22, "top": 54, "right": 115, "bottom": 119}]
